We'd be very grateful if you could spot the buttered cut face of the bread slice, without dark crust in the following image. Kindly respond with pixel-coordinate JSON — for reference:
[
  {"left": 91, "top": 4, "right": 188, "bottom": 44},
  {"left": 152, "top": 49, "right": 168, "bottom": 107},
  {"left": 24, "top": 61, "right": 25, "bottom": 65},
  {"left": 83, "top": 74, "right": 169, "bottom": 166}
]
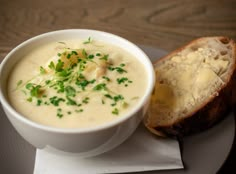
[{"left": 145, "top": 37, "right": 235, "bottom": 128}]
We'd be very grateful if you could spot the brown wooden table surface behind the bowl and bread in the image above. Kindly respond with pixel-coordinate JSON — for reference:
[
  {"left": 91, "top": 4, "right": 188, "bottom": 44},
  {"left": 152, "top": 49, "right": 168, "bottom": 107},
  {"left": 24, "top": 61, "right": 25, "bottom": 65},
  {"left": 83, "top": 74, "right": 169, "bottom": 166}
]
[{"left": 0, "top": 0, "right": 236, "bottom": 173}]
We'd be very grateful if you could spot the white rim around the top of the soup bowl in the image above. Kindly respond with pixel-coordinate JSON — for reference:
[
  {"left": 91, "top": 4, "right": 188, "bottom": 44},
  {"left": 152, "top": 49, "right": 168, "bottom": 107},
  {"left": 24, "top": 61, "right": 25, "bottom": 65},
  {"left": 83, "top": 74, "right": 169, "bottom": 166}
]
[{"left": 0, "top": 29, "right": 155, "bottom": 134}]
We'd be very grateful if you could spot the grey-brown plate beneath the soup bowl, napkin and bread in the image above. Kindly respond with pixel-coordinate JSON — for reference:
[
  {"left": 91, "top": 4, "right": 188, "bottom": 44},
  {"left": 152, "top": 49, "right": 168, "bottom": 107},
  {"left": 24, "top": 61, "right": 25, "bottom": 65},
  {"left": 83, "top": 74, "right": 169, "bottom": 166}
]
[{"left": 0, "top": 46, "right": 235, "bottom": 174}]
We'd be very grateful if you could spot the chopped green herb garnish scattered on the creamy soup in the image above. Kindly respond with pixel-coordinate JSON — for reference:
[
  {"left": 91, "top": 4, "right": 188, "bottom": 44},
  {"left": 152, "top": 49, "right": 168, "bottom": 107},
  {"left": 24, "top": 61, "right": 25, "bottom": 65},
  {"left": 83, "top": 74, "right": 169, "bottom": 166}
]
[{"left": 17, "top": 44, "right": 132, "bottom": 118}]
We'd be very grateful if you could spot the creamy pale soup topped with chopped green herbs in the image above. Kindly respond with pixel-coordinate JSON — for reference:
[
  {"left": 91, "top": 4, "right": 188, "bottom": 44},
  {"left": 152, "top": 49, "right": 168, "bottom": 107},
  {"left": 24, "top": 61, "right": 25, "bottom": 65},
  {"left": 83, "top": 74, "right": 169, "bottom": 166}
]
[{"left": 8, "top": 38, "right": 147, "bottom": 128}]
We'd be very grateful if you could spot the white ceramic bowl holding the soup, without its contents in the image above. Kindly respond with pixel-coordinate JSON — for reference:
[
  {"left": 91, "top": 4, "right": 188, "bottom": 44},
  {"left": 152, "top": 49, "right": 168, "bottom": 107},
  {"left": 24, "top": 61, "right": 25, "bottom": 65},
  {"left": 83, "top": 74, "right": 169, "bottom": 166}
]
[{"left": 0, "top": 29, "right": 155, "bottom": 157}]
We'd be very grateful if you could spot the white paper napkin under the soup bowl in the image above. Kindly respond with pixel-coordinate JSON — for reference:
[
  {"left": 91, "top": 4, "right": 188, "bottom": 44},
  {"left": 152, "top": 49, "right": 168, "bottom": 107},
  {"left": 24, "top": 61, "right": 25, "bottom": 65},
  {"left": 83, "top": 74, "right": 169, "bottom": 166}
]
[{"left": 34, "top": 125, "right": 183, "bottom": 174}]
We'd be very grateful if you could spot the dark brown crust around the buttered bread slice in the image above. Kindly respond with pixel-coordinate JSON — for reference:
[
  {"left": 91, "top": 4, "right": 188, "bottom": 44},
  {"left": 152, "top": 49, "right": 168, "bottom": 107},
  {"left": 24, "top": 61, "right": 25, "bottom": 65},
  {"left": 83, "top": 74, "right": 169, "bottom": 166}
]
[{"left": 145, "top": 36, "right": 236, "bottom": 137}]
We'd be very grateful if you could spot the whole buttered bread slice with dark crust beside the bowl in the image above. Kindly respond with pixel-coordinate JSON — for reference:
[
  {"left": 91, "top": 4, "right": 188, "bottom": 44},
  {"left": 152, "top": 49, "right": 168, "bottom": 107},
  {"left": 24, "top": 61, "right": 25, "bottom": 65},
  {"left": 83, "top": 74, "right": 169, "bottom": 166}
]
[{"left": 144, "top": 37, "right": 236, "bottom": 136}]
